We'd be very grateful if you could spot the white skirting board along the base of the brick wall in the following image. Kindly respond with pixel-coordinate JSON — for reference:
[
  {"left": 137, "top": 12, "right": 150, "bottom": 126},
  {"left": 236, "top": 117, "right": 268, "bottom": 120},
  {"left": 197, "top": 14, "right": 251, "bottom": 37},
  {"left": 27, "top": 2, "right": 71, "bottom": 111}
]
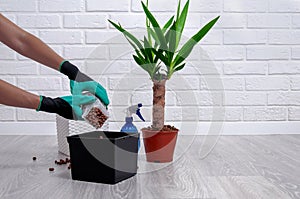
[{"left": 0, "top": 122, "right": 300, "bottom": 135}]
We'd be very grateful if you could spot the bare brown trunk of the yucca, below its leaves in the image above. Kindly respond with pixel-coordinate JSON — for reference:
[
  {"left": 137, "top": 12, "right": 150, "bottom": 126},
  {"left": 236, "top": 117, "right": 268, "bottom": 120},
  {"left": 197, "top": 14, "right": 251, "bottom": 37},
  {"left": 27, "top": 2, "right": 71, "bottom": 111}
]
[{"left": 152, "top": 79, "right": 166, "bottom": 131}]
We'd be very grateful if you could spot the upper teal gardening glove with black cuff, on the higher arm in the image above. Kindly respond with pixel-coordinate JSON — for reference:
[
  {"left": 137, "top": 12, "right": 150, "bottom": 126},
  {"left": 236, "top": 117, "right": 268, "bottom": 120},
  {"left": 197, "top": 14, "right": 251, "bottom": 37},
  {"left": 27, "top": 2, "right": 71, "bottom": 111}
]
[{"left": 59, "top": 61, "right": 109, "bottom": 106}]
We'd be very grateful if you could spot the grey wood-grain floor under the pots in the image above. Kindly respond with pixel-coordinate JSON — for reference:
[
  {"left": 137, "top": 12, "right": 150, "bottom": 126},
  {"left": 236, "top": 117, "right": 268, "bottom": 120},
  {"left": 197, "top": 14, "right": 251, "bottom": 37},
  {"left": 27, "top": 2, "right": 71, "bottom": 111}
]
[{"left": 0, "top": 135, "right": 300, "bottom": 199}]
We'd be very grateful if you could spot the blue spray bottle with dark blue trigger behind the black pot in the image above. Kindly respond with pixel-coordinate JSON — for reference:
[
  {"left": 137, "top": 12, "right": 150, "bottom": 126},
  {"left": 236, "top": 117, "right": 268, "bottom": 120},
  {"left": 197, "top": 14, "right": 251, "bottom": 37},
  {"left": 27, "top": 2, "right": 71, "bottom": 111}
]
[{"left": 121, "top": 103, "right": 145, "bottom": 148}]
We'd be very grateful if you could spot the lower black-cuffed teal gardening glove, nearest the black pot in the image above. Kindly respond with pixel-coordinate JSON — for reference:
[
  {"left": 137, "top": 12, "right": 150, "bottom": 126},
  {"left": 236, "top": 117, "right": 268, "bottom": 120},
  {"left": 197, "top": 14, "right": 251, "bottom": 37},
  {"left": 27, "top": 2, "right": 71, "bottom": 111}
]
[{"left": 36, "top": 95, "right": 96, "bottom": 120}]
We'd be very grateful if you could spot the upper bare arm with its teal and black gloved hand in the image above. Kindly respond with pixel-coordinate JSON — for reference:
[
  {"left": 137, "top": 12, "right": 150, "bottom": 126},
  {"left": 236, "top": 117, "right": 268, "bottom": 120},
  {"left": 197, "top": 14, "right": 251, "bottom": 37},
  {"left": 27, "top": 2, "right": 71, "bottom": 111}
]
[{"left": 0, "top": 14, "right": 109, "bottom": 105}]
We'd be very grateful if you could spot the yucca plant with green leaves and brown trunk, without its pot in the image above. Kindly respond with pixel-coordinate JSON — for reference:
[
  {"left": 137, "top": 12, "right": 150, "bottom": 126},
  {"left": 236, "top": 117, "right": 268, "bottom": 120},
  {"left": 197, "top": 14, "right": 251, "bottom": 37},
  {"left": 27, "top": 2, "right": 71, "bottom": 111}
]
[{"left": 109, "top": 0, "right": 219, "bottom": 130}]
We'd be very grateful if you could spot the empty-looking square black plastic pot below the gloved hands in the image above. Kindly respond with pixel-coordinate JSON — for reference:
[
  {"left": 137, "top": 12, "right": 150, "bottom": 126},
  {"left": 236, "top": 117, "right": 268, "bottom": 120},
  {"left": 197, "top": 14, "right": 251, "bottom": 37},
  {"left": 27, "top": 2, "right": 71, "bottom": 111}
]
[{"left": 67, "top": 131, "right": 139, "bottom": 184}]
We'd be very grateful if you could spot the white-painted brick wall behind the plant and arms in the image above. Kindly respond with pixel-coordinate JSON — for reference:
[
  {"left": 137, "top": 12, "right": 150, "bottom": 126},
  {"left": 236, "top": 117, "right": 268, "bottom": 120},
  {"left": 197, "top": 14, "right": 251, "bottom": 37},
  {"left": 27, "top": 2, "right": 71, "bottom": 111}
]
[{"left": 0, "top": 0, "right": 300, "bottom": 125}]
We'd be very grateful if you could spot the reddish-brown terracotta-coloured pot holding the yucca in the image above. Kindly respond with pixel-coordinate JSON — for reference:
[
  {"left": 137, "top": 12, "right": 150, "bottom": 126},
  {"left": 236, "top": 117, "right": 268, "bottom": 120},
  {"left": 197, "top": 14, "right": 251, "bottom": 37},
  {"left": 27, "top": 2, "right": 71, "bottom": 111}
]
[{"left": 142, "top": 129, "right": 178, "bottom": 163}]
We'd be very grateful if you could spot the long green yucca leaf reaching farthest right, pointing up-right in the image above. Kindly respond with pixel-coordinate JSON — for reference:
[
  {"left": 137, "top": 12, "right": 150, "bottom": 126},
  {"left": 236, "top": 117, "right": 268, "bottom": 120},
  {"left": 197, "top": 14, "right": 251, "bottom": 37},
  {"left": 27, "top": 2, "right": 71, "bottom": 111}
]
[{"left": 173, "top": 16, "right": 220, "bottom": 66}]
